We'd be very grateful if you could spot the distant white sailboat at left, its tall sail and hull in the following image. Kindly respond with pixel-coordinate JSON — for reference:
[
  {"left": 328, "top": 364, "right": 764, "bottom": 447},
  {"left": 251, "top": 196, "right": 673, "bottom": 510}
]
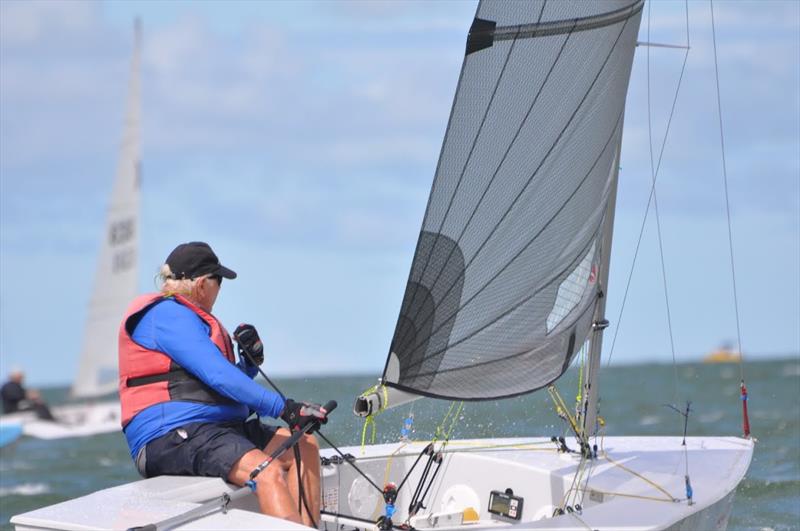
[{"left": 17, "top": 22, "right": 141, "bottom": 439}]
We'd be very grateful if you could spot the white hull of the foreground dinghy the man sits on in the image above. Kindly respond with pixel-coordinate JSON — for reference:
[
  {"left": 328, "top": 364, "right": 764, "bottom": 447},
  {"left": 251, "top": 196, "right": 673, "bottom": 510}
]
[{"left": 11, "top": 437, "right": 753, "bottom": 531}]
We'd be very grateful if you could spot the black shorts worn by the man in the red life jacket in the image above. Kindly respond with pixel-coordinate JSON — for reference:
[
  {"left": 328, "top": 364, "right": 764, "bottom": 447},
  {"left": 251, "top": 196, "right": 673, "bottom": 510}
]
[{"left": 142, "top": 419, "right": 277, "bottom": 481}]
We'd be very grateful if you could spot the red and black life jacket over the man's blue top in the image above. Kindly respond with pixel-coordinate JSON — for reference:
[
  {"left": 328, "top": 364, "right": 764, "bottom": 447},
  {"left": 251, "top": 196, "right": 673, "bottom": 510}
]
[{"left": 119, "top": 293, "right": 236, "bottom": 428}]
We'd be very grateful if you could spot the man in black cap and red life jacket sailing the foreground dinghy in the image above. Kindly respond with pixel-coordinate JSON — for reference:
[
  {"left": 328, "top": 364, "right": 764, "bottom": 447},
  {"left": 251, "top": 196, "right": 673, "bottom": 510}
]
[{"left": 119, "top": 242, "right": 327, "bottom": 527}]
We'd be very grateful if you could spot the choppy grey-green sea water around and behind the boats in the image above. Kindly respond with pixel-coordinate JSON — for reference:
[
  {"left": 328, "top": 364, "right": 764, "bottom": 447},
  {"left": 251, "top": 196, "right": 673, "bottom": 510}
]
[{"left": 0, "top": 356, "right": 800, "bottom": 530}]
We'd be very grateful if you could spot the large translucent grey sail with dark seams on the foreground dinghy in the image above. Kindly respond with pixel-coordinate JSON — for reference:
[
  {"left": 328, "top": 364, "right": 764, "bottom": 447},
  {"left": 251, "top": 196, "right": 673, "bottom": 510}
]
[{"left": 382, "top": 0, "right": 643, "bottom": 400}]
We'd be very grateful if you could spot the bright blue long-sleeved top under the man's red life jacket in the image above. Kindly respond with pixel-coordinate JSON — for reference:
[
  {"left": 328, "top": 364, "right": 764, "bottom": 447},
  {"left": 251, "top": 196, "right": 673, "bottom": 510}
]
[{"left": 124, "top": 299, "right": 284, "bottom": 459}]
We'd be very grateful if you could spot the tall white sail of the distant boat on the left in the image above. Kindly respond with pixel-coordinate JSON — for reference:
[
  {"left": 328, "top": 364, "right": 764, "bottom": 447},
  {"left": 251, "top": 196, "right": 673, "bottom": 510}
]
[{"left": 71, "top": 21, "right": 141, "bottom": 397}]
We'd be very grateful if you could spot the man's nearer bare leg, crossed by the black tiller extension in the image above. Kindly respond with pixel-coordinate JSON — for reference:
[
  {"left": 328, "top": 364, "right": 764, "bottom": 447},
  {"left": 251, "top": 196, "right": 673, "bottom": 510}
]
[{"left": 228, "top": 441, "right": 302, "bottom": 523}]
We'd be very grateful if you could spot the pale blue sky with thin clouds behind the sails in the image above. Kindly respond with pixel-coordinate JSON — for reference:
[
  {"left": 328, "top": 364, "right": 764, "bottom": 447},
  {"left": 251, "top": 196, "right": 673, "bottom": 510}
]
[{"left": 0, "top": 0, "right": 800, "bottom": 385}]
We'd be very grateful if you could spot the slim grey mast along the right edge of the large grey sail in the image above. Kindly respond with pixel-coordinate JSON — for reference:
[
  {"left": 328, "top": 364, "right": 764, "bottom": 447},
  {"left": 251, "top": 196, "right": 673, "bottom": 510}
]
[{"left": 581, "top": 137, "right": 624, "bottom": 444}]
